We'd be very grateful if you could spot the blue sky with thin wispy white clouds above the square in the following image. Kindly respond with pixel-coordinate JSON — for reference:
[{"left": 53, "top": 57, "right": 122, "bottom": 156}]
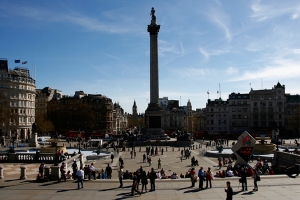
[{"left": 0, "top": 0, "right": 300, "bottom": 113}]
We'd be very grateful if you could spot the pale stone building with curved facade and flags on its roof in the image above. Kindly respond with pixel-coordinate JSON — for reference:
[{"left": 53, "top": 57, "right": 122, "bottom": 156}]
[{"left": 0, "top": 59, "right": 36, "bottom": 139}]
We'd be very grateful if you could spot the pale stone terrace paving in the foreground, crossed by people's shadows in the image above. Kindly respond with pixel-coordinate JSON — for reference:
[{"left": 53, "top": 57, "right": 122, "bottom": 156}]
[{"left": 0, "top": 176, "right": 300, "bottom": 200}]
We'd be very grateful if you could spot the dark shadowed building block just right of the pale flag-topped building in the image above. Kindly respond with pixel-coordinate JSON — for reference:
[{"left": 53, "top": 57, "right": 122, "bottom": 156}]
[{"left": 48, "top": 91, "right": 127, "bottom": 133}]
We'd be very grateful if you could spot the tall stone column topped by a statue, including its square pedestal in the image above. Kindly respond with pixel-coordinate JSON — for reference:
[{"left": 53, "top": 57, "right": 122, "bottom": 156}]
[{"left": 145, "top": 8, "right": 164, "bottom": 136}]
